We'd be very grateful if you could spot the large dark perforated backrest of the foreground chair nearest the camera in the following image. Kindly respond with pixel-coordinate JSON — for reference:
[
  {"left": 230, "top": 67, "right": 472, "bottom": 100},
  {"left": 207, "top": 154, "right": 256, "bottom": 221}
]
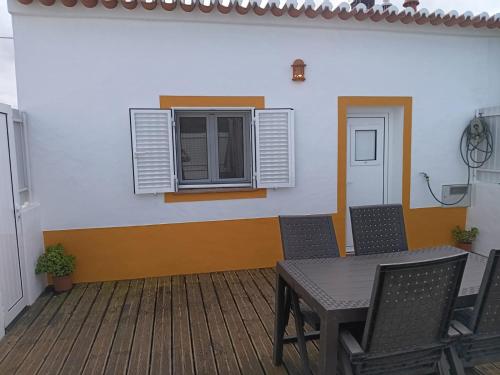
[{"left": 362, "top": 254, "right": 467, "bottom": 353}]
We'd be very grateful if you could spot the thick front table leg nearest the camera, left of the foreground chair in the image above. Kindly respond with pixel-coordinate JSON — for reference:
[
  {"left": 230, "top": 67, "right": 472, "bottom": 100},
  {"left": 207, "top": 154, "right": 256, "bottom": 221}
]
[{"left": 319, "top": 314, "right": 339, "bottom": 375}]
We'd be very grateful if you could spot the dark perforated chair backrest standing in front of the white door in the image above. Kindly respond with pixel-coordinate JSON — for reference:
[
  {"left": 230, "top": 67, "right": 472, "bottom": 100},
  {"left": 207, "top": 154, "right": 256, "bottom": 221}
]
[{"left": 349, "top": 204, "right": 408, "bottom": 255}]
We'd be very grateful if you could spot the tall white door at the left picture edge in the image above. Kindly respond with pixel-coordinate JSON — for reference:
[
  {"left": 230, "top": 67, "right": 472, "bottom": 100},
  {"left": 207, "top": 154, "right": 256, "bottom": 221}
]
[{"left": 0, "top": 107, "right": 26, "bottom": 328}]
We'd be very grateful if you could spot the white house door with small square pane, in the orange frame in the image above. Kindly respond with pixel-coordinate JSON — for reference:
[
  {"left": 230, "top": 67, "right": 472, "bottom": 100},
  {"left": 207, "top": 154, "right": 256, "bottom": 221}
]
[{"left": 346, "top": 117, "right": 388, "bottom": 251}]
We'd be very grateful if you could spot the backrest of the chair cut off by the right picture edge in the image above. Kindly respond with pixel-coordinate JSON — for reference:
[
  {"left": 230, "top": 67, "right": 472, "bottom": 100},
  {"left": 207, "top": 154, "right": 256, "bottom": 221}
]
[{"left": 469, "top": 250, "right": 500, "bottom": 335}]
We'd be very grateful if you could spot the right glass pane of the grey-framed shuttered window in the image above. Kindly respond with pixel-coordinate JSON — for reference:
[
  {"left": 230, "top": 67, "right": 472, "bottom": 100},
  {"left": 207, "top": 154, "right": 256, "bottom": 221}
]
[{"left": 217, "top": 117, "right": 245, "bottom": 179}]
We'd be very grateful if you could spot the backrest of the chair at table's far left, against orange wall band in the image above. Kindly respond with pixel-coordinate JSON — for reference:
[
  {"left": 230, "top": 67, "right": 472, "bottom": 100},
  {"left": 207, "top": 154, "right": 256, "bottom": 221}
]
[{"left": 279, "top": 215, "right": 339, "bottom": 259}]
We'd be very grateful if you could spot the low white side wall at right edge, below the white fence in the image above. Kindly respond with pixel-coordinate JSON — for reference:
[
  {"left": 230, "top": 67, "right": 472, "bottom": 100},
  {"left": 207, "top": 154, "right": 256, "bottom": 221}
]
[{"left": 467, "top": 183, "right": 500, "bottom": 255}]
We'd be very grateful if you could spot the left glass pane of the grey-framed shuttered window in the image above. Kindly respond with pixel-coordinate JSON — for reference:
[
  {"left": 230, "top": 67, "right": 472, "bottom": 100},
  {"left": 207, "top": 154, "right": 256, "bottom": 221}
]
[{"left": 180, "top": 117, "right": 208, "bottom": 180}]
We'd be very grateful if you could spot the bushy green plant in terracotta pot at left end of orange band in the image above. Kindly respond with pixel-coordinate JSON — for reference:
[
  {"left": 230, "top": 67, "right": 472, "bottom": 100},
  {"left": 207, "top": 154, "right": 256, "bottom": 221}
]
[{"left": 35, "top": 244, "right": 75, "bottom": 293}]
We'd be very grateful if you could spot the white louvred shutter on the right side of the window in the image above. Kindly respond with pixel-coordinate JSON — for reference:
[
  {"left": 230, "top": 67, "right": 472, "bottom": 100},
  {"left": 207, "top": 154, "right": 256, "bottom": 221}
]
[{"left": 255, "top": 109, "right": 295, "bottom": 188}]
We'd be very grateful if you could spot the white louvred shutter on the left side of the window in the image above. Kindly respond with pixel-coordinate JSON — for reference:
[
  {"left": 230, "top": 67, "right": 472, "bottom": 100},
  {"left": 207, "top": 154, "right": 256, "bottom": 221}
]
[{"left": 130, "top": 109, "right": 176, "bottom": 194}]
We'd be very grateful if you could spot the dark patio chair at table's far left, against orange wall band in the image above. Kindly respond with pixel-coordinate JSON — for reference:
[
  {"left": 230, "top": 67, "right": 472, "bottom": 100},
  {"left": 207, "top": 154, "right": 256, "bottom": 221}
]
[{"left": 279, "top": 215, "right": 339, "bottom": 372}]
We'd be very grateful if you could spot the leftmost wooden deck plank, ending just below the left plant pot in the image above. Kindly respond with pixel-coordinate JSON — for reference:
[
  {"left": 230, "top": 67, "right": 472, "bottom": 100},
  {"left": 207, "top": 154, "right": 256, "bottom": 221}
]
[{"left": 0, "top": 292, "right": 53, "bottom": 363}]
